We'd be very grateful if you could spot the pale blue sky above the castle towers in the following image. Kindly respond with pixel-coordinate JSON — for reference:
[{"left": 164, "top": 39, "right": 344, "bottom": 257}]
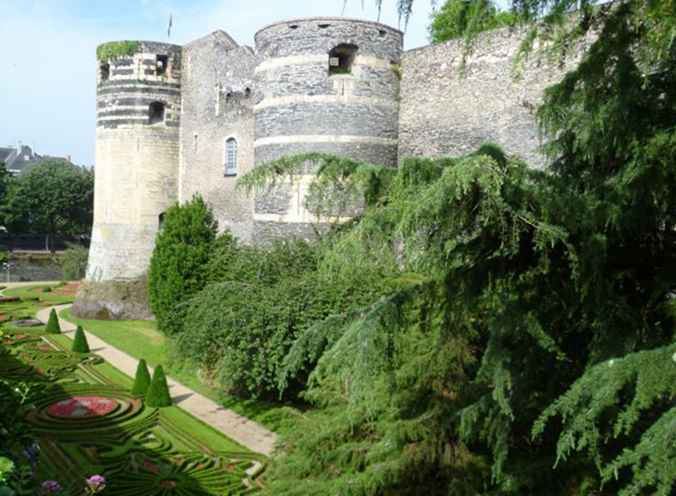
[{"left": 0, "top": 0, "right": 432, "bottom": 165}]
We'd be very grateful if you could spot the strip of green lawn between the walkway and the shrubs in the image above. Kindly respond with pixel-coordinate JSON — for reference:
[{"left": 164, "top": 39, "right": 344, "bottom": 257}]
[{"left": 60, "top": 309, "right": 290, "bottom": 433}]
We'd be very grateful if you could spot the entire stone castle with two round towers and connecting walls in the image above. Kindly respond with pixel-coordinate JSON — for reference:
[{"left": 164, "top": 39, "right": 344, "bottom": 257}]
[{"left": 80, "top": 17, "right": 561, "bottom": 318}]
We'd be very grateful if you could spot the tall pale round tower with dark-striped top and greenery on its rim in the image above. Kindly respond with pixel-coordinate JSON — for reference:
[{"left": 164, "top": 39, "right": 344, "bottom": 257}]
[{"left": 74, "top": 37, "right": 181, "bottom": 318}]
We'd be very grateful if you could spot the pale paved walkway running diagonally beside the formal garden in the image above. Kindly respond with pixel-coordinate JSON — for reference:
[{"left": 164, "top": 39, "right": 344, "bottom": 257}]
[{"left": 31, "top": 298, "right": 277, "bottom": 456}]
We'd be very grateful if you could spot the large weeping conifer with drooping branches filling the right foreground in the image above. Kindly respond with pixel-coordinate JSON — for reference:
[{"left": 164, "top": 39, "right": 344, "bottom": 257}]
[{"left": 230, "top": 0, "right": 676, "bottom": 496}]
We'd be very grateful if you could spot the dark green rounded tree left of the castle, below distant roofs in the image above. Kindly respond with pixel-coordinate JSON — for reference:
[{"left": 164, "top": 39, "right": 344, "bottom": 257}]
[{"left": 6, "top": 160, "right": 94, "bottom": 247}]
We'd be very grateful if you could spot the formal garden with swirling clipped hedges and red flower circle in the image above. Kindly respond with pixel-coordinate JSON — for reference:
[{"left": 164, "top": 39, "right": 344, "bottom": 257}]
[{"left": 0, "top": 290, "right": 264, "bottom": 496}]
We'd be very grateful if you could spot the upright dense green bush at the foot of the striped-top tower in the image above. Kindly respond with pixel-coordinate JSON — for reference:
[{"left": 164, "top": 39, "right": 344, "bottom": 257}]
[{"left": 148, "top": 196, "right": 217, "bottom": 334}]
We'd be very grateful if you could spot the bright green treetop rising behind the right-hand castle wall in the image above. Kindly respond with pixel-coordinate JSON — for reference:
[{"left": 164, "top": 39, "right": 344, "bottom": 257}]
[{"left": 429, "top": 0, "right": 516, "bottom": 43}]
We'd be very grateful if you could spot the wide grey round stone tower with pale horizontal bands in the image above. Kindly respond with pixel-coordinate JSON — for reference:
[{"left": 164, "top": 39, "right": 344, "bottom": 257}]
[{"left": 254, "top": 17, "right": 403, "bottom": 241}]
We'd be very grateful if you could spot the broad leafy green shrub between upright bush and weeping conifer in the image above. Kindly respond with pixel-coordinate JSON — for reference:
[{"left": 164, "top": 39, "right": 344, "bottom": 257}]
[{"left": 176, "top": 234, "right": 394, "bottom": 396}]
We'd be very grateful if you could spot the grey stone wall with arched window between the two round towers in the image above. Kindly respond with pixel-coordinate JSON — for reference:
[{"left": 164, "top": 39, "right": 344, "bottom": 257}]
[{"left": 179, "top": 31, "right": 258, "bottom": 242}]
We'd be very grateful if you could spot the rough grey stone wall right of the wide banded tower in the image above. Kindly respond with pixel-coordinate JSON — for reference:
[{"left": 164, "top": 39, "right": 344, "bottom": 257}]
[{"left": 399, "top": 29, "right": 564, "bottom": 167}]
